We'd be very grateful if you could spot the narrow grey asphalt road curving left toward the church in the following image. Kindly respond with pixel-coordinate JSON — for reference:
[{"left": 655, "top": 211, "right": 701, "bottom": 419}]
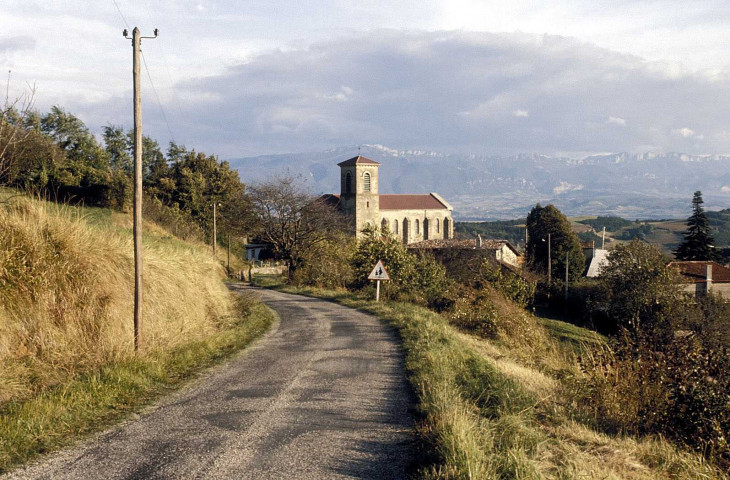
[{"left": 4, "top": 290, "right": 415, "bottom": 479}]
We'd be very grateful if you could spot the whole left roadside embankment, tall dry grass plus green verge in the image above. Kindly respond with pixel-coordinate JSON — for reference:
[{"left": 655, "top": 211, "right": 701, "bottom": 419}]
[{"left": 0, "top": 195, "right": 273, "bottom": 472}]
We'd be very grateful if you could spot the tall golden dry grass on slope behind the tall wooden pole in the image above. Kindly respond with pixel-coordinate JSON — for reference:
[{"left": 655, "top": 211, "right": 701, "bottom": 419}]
[{"left": 0, "top": 198, "right": 233, "bottom": 404}]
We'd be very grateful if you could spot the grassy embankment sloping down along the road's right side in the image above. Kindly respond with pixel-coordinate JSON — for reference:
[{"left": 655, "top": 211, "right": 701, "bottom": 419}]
[{"left": 252, "top": 279, "right": 726, "bottom": 479}]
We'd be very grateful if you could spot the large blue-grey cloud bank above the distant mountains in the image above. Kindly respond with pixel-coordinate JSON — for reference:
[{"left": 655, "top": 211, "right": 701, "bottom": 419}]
[{"left": 155, "top": 31, "right": 730, "bottom": 156}]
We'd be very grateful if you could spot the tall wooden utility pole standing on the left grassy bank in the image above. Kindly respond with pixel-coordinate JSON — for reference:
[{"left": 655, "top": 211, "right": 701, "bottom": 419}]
[{"left": 123, "top": 27, "right": 157, "bottom": 352}]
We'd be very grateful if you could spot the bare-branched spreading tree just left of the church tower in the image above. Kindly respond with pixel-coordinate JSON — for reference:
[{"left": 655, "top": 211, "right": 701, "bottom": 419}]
[{"left": 249, "top": 174, "right": 345, "bottom": 278}]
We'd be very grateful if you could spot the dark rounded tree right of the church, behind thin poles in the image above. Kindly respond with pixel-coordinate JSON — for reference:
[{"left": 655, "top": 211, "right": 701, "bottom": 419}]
[{"left": 527, "top": 203, "right": 585, "bottom": 280}]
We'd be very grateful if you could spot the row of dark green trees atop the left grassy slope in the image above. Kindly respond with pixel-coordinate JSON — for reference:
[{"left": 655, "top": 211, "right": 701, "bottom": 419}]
[{"left": 0, "top": 98, "right": 253, "bottom": 244}]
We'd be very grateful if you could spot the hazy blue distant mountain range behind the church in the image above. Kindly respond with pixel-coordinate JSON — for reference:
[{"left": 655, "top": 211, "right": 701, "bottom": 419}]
[{"left": 229, "top": 145, "right": 730, "bottom": 220}]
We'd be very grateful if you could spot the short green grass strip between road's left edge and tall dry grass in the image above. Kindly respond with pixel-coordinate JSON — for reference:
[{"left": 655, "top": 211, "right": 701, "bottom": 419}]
[{"left": 0, "top": 294, "right": 274, "bottom": 473}]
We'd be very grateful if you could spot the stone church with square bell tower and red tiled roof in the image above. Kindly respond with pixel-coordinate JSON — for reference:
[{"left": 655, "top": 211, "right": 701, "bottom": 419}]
[{"left": 324, "top": 155, "right": 454, "bottom": 244}]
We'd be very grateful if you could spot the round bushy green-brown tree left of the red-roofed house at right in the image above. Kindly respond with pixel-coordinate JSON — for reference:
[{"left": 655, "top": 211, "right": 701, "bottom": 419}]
[{"left": 598, "top": 240, "right": 681, "bottom": 333}]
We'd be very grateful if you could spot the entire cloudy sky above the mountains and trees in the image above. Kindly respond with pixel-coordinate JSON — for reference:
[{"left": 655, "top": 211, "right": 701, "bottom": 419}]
[{"left": 0, "top": 0, "right": 730, "bottom": 158}]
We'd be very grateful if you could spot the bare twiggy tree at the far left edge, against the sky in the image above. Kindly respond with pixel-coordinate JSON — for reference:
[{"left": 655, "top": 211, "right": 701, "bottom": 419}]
[{"left": 0, "top": 76, "right": 35, "bottom": 183}]
